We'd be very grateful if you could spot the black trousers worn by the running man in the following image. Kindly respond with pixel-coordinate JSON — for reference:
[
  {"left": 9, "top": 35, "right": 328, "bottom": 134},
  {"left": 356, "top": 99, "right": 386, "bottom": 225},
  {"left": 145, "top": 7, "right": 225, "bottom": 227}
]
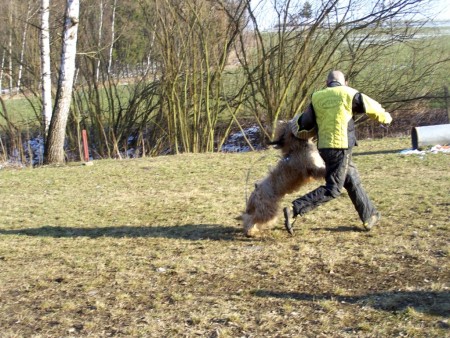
[{"left": 292, "top": 148, "right": 376, "bottom": 223}]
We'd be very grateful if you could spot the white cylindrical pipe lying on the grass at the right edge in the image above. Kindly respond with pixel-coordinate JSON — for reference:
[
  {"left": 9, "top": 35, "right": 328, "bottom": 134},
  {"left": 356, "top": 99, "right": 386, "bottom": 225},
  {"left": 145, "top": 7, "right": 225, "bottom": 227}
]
[{"left": 411, "top": 124, "right": 450, "bottom": 149}]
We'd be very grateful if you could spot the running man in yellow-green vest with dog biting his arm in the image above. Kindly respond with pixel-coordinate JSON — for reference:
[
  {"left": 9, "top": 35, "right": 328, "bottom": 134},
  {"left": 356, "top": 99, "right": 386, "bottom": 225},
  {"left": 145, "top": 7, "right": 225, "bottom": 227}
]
[{"left": 283, "top": 71, "right": 392, "bottom": 235}]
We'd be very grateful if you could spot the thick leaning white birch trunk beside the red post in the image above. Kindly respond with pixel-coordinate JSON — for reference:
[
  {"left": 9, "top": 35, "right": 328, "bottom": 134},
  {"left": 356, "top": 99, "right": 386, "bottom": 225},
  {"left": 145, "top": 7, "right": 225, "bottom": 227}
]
[{"left": 44, "top": 0, "right": 80, "bottom": 164}]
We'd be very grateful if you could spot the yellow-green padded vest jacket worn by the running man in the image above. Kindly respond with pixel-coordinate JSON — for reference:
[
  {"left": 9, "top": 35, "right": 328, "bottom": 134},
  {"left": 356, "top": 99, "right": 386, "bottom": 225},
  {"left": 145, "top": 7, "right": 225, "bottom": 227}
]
[{"left": 312, "top": 86, "right": 392, "bottom": 149}]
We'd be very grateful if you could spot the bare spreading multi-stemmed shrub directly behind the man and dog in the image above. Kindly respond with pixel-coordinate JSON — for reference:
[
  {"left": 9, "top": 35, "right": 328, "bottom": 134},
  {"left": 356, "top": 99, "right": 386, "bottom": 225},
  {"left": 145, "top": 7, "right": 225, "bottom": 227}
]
[{"left": 239, "top": 0, "right": 442, "bottom": 137}]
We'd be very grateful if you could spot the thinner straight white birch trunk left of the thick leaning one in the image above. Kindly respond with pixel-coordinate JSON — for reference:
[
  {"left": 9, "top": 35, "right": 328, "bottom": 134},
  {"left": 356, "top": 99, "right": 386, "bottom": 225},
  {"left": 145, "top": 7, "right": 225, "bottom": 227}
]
[{"left": 41, "top": 0, "right": 52, "bottom": 137}]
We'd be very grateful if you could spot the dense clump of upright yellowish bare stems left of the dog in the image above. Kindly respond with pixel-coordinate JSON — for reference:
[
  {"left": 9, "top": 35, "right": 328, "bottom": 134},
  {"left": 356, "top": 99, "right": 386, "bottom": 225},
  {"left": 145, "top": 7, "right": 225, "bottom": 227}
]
[{"left": 155, "top": 0, "right": 244, "bottom": 153}]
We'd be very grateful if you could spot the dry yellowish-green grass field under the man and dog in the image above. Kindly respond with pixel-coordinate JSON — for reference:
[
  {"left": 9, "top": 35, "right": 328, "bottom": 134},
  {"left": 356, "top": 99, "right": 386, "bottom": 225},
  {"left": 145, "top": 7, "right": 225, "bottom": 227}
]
[{"left": 0, "top": 138, "right": 450, "bottom": 338}]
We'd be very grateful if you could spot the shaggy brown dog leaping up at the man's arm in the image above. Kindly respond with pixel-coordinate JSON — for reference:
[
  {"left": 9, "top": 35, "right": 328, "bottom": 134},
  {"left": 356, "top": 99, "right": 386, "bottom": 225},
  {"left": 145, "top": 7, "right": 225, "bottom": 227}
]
[{"left": 242, "top": 123, "right": 325, "bottom": 237}]
